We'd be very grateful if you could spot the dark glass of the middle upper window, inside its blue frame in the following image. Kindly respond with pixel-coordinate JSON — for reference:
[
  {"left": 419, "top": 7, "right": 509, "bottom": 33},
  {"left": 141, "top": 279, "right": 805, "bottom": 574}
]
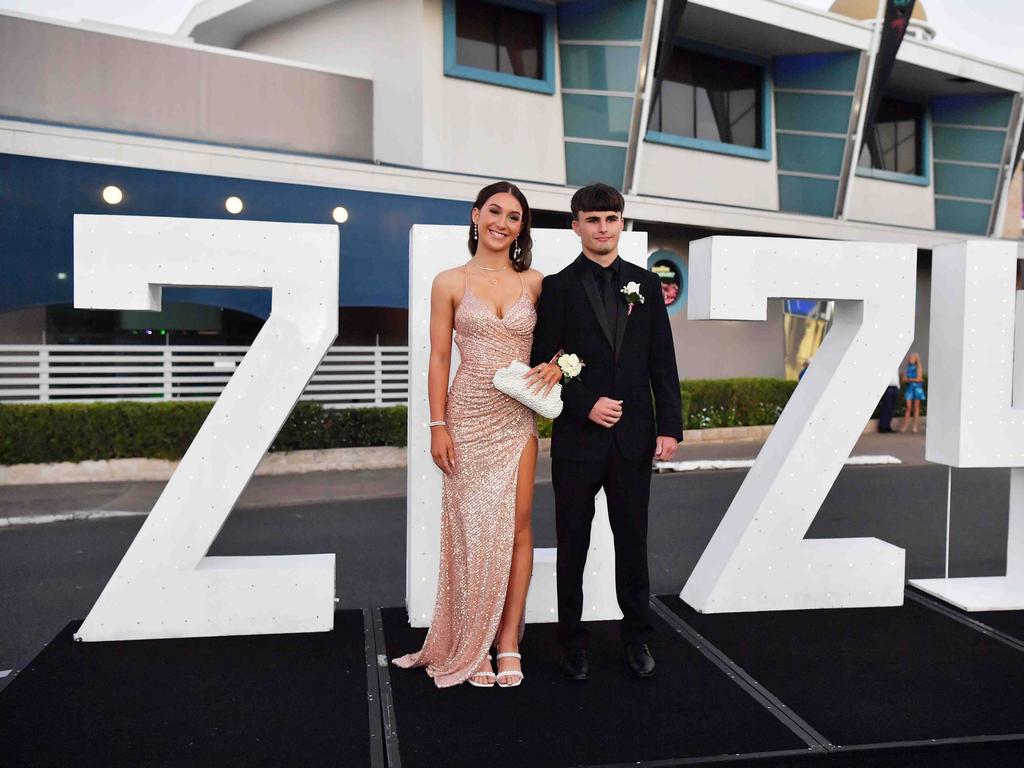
[{"left": 649, "top": 48, "right": 764, "bottom": 148}]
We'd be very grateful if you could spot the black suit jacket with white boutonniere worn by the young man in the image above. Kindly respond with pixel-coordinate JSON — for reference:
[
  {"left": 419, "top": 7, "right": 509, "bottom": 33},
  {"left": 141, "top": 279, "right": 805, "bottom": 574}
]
[{"left": 530, "top": 254, "right": 683, "bottom": 461}]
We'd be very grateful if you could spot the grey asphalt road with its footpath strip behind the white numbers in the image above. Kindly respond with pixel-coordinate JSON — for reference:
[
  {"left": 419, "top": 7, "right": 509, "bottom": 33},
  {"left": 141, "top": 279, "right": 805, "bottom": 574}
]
[{"left": 0, "top": 434, "right": 1009, "bottom": 687}]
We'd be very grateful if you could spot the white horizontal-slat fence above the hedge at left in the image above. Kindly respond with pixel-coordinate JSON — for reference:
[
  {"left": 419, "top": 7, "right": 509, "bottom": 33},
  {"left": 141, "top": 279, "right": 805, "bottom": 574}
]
[{"left": 0, "top": 344, "right": 409, "bottom": 408}]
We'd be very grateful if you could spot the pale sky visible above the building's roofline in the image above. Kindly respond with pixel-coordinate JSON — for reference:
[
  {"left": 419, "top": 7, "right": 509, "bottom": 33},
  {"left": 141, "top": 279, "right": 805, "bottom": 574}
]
[{"left": 0, "top": 0, "right": 1024, "bottom": 70}]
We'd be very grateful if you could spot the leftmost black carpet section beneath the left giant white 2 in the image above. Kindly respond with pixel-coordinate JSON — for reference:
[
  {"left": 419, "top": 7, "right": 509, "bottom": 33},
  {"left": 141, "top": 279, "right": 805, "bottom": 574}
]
[{"left": 0, "top": 610, "right": 383, "bottom": 768}]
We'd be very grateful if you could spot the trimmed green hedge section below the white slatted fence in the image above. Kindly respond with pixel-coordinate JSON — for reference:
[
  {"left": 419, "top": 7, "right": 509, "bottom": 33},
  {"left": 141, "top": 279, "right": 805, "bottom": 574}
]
[{"left": 0, "top": 401, "right": 406, "bottom": 464}]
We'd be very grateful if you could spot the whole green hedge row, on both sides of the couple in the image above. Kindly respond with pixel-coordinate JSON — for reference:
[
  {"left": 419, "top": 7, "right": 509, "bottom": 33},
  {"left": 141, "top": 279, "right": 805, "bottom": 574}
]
[{"left": 0, "top": 379, "right": 925, "bottom": 464}]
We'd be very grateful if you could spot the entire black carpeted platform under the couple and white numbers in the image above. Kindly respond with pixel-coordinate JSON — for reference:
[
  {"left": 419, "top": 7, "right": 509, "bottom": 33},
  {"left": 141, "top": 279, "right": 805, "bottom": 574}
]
[{"left": 12, "top": 602, "right": 1024, "bottom": 768}]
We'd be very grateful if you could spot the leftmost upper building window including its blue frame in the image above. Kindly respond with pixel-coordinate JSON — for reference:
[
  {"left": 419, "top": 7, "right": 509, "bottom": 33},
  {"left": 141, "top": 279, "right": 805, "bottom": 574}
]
[{"left": 444, "top": 0, "right": 555, "bottom": 93}]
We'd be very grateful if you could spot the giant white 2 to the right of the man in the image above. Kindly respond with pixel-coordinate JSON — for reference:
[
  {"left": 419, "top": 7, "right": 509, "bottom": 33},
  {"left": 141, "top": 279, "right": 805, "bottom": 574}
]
[{"left": 681, "top": 237, "right": 915, "bottom": 613}]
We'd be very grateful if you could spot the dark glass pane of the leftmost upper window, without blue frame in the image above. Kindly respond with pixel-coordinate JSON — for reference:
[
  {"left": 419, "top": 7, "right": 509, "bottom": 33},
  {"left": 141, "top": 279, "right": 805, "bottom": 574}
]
[{"left": 455, "top": 0, "right": 546, "bottom": 80}]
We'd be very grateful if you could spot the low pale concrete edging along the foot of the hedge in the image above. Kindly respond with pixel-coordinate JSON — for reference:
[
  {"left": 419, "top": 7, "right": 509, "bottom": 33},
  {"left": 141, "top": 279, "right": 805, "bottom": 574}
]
[{"left": 0, "top": 417, "right": 926, "bottom": 485}]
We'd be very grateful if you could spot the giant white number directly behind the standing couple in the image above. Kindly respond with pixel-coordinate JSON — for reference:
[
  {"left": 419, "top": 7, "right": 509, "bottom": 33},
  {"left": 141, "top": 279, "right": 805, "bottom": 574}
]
[{"left": 406, "top": 224, "right": 647, "bottom": 627}]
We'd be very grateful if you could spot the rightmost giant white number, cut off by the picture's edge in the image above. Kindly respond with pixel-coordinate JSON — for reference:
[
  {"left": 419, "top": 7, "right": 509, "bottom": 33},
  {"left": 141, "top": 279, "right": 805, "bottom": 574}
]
[{"left": 910, "top": 242, "right": 1024, "bottom": 610}]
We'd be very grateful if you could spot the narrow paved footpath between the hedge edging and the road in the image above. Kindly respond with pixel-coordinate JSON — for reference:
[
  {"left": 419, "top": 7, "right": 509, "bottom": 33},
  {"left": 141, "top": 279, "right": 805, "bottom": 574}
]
[{"left": 0, "top": 433, "right": 926, "bottom": 521}]
